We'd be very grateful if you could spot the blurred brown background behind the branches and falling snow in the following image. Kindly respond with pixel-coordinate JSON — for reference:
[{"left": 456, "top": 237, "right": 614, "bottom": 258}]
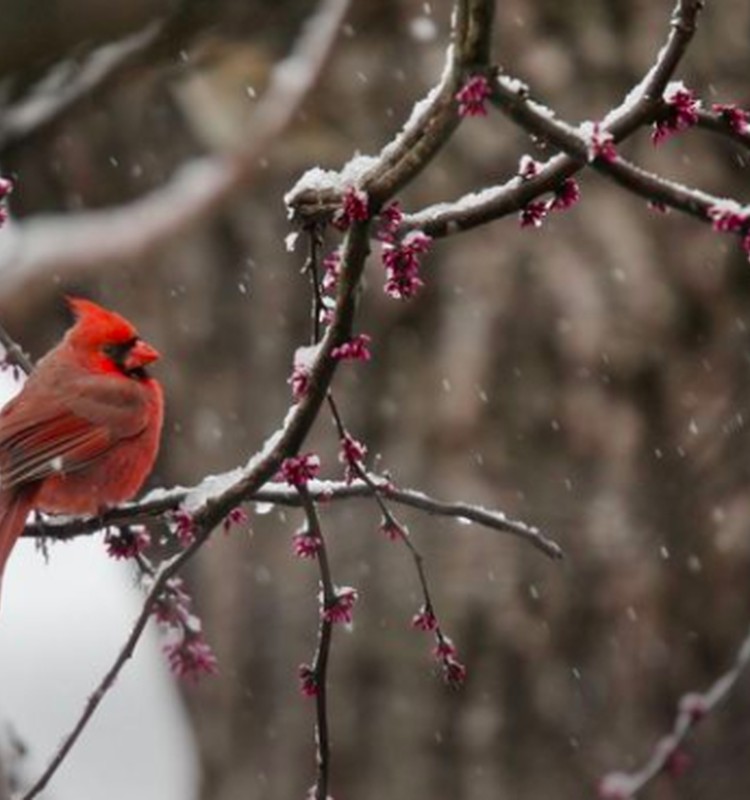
[{"left": 0, "top": 0, "right": 750, "bottom": 800}]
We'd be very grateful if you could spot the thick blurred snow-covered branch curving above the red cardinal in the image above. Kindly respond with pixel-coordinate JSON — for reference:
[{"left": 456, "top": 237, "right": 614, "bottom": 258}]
[{"left": 0, "top": 0, "right": 349, "bottom": 293}]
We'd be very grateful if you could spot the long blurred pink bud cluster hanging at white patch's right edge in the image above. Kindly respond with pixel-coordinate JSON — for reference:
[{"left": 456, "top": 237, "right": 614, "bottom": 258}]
[{"left": 152, "top": 578, "right": 218, "bottom": 680}]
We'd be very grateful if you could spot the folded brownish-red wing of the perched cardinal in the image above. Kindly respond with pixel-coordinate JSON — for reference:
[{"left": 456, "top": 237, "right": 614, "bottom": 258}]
[{"left": 0, "top": 407, "right": 116, "bottom": 489}]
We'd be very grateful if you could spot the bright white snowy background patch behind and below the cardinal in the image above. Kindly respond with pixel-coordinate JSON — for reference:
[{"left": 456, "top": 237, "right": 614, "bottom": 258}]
[{"left": 0, "top": 372, "right": 198, "bottom": 800}]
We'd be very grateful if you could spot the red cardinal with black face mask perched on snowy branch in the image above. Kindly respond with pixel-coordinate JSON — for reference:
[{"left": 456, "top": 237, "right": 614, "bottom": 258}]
[{"left": 0, "top": 298, "right": 164, "bottom": 582}]
